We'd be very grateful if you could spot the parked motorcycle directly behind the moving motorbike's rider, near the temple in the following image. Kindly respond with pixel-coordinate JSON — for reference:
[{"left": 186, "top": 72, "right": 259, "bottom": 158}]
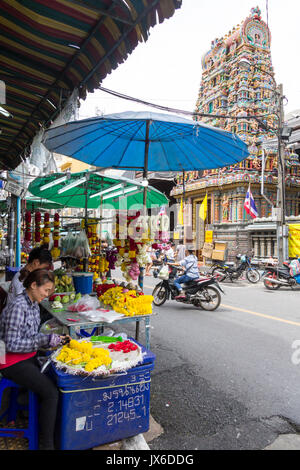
[{"left": 211, "top": 255, "right": 260, "bottom": 284}]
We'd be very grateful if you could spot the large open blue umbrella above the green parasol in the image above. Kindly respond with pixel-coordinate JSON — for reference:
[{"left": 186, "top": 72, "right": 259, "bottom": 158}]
[{"left": 44, "top": 111, "right": 249, "bottom": 171}]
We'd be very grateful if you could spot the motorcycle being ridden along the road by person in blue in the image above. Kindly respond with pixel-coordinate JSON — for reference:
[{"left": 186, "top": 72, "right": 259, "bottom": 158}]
[{"left": 152, "top": 266, "right": 224, "bottom": 311}]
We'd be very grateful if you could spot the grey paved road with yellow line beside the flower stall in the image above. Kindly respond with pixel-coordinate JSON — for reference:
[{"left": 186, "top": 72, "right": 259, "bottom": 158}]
[{"left": 110, "top": 278, "right": 300, "bottom": 450}]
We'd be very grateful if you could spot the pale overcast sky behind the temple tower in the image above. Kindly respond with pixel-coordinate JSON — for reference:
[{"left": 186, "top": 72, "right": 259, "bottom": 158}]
[{"left": 80, "top": 0, "right": 300, "bottom": 118}]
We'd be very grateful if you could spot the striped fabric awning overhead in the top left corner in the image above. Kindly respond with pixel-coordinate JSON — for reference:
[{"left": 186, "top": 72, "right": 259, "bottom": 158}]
[{"left": 0, "top": 0, "right": 181, "bottom": 169}]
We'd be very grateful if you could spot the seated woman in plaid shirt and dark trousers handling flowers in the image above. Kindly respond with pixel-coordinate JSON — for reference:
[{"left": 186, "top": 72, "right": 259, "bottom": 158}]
[{"left": 0, "top": 269, "right": 66, "bottom": 449}]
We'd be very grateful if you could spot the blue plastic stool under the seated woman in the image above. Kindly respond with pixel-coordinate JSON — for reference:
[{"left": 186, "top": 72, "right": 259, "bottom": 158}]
[{"left": 0, "top": 376, "right": 38, "bottom": 450}]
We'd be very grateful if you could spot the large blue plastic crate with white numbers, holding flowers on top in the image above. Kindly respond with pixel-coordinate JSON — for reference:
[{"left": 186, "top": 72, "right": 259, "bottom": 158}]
[{"left": 51, "top": 347, "right": 155, "bottom": 450}]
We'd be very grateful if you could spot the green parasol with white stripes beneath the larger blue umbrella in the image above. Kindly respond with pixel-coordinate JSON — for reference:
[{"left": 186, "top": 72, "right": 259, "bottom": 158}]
[{"left": 29, "top": 171, "right": 169, "bottom": 209}]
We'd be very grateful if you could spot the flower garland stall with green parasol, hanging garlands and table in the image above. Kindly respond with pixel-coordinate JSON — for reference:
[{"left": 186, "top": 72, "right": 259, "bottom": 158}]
[{"left": 25, "top": 171, "right": 168, "bottom": 347}]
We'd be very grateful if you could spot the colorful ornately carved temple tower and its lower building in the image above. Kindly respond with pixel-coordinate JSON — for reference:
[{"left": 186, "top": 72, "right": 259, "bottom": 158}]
[{"left": 171, "top": 7, "right": 300, "bottom": 259}]
